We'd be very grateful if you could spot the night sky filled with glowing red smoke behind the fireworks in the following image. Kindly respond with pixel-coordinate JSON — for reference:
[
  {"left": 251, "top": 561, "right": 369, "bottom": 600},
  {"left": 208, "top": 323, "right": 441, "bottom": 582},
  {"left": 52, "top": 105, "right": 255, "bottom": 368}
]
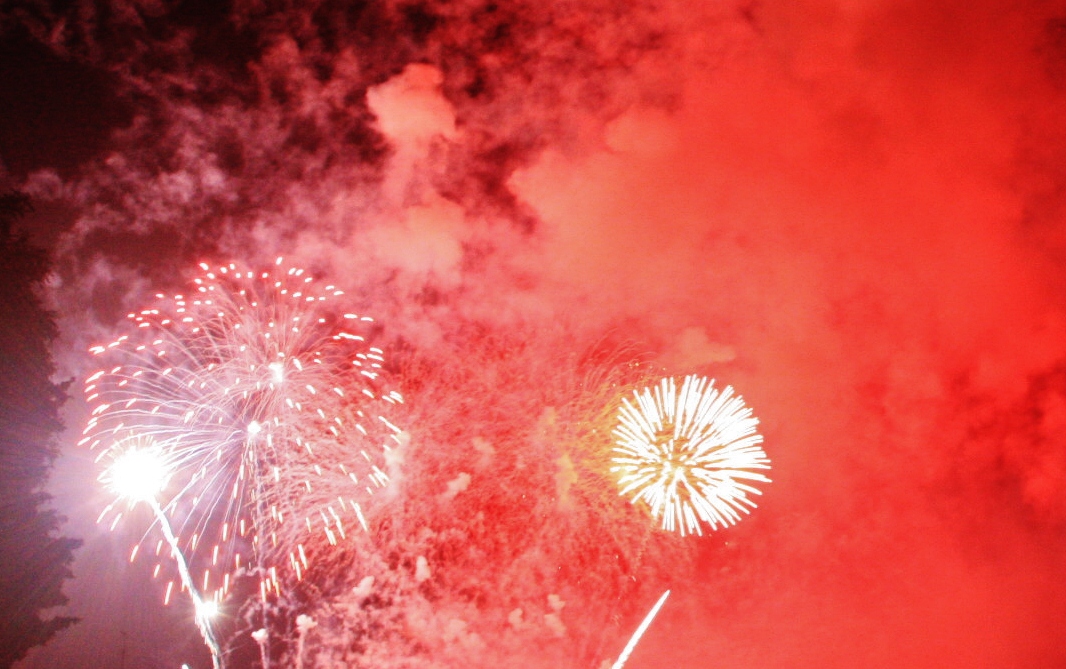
[{"left": 0, "top": 0, "right": 1066, "bottom": 669}]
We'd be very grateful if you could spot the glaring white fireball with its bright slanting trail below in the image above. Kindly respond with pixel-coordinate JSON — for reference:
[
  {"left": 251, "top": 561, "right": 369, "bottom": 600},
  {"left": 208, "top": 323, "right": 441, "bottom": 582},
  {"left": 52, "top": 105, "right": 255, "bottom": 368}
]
[{"left": 100, "top": 437, "right": 222, "bottom": 669}]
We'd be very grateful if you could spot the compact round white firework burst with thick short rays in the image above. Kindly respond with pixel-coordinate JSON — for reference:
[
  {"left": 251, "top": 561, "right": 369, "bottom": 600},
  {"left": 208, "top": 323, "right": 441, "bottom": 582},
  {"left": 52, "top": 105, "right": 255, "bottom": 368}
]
[{"left": 611, "top": 376, "right": 770, "bottom": 535}]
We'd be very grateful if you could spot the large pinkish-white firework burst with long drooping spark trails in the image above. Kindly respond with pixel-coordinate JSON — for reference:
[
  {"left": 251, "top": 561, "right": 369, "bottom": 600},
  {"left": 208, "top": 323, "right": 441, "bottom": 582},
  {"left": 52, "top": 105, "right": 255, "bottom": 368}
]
[{"left": 81, "top": 259, "right": 402, "bottom": 604}]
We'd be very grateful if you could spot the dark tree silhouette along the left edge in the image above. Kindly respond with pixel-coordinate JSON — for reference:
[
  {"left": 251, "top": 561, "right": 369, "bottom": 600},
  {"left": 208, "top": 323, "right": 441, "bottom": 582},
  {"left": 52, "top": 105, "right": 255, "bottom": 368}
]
[{"left": 0, "top": 192, "right": 80, "bottom": 669}]
